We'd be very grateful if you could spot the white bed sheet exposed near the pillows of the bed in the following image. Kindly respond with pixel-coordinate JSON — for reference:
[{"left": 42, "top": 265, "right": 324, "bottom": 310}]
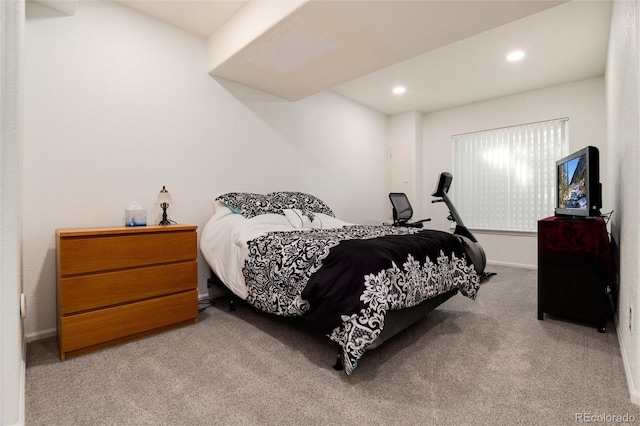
[{"left": 200, "top": 206, "right": 353, "bottom": 299}]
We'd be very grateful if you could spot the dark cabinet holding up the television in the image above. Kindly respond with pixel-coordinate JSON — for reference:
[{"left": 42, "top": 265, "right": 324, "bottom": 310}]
[{"left": 538, "top": 216, "right": 616, "bottom": 333}]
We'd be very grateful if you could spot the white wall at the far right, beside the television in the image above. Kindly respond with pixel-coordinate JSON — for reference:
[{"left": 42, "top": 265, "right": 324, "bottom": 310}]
[{"left": 604, "top": 0, "right": 640, "bottom": 404}]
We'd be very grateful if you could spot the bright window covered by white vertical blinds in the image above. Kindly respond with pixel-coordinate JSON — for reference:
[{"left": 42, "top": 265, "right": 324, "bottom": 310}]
[{"left": 453, "top": 118, "right": 569, "bottom": 232}]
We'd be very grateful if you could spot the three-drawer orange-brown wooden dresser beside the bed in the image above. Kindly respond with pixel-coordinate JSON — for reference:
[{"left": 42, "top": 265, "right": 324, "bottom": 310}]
[{"left": 56, "top": 225, "right": 198, "bottom": 361}]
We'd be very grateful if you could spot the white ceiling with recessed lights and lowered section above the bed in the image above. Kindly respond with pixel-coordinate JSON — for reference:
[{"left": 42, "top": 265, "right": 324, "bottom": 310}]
[{"left": 112, "top": 0, "right": 611, "bottom": 114}]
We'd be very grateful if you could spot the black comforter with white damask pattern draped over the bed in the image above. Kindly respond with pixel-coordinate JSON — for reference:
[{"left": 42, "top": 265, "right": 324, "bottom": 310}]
[{"left": 201, "top": 205, "right": 479, "bottom": 374}]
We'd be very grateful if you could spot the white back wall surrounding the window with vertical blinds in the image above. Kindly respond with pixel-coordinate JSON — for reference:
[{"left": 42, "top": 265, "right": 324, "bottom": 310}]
[{"left": 423, "top": 77, "right": 612, "bottom": 268}]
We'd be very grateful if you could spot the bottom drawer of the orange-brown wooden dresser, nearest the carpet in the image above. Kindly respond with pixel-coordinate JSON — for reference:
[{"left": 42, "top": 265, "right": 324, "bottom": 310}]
[{"left": 59, "top": 290, "right": 198, "bottom": 359}]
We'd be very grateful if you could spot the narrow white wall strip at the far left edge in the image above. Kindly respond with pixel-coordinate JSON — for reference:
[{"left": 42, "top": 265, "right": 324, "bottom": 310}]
[{"left": 0, "top": 1, "right": 26, "bottom": 425}]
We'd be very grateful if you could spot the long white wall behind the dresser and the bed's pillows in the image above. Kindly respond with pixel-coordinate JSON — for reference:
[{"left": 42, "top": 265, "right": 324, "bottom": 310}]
[{"left": 24, "top": 2, "right": 388, "bottom": 338}]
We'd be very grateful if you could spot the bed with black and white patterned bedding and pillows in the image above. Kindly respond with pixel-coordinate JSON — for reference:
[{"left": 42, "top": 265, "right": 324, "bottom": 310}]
[{"left": 200, "top": 192, "right": 479, "bottom": 374}]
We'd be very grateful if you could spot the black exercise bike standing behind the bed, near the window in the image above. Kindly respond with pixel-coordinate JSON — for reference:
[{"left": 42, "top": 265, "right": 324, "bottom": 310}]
[{"left": 431, "top": 172, "right": 496, "bottom": 281}]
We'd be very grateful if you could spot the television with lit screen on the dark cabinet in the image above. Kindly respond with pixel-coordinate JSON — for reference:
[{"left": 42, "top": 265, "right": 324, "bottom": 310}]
[{"left": 556, "top": 146, "right": 602, "bottom": 218}]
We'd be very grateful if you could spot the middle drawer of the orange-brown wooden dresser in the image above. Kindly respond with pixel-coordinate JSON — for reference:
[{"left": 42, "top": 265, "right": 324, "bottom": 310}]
[{"left": 59, "top": 261, "right": 198, "bottom": 315}]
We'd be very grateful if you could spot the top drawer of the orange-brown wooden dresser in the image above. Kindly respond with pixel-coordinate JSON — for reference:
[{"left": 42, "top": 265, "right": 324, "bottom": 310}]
[{"left": 58, "top": 232, "right": 197, "bottom": 277}]
